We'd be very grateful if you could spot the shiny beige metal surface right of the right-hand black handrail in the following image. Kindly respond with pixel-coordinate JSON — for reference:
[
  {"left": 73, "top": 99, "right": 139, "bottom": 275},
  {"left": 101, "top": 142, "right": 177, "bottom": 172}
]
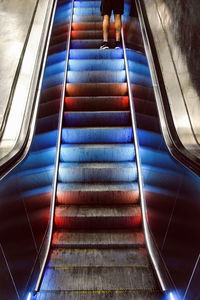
[{"left": 143, "top": 0, "right": 200, "bottom": 158}]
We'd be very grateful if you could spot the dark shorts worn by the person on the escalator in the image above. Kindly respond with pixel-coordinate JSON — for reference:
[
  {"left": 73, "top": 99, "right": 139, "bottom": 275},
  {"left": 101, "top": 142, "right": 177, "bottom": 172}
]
[{"left": 100, "top": 0, "right": 124, "bottom": 16}]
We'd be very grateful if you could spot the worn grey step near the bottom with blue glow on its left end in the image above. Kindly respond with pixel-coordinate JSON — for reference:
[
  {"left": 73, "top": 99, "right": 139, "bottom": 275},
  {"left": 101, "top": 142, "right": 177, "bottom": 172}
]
[{"left": 41, "top": 267, "right": 156, "bottom": 291}]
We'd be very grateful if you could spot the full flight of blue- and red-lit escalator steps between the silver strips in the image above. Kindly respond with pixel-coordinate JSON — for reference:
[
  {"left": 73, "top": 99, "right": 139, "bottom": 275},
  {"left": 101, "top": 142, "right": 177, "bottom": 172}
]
[{"left": 32, "top": 1, "right": 161, "bottom": 299}]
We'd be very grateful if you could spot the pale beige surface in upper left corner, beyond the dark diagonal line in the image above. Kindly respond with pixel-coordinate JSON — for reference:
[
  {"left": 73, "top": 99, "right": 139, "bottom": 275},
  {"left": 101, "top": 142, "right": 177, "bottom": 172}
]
[{"left": 0, "top": 0, "right": 37, "bottom": 126}]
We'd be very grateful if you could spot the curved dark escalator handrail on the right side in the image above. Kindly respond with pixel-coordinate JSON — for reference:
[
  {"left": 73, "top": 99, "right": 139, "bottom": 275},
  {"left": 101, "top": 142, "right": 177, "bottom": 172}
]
[{"left": 136, "top": 0, "right": 200, "bottom": 176}]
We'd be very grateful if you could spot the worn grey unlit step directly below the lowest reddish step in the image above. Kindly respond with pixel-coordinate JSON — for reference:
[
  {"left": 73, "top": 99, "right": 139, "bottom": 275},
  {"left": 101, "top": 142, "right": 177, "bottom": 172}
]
[{"left": 48, "top": 248, "right": 150, "bottom": 267}]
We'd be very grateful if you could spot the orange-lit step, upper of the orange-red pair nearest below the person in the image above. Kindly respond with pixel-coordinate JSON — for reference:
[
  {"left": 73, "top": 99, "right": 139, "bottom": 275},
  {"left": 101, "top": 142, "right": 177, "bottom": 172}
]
[{"left": 66, "top": 83, "right": 128, "bottom": 97}]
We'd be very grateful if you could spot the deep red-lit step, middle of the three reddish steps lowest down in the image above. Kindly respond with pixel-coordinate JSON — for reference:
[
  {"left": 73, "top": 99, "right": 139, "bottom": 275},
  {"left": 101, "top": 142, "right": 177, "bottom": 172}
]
[{"left": 54, "top": 205, "right": 142, "bottom": 230}]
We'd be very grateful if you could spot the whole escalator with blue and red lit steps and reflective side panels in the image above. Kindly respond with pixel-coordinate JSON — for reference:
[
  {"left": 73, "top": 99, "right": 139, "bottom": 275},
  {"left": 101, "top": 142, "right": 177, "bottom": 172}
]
[{"left": 0, "top": 0, "right": 200, "bottom": 300}]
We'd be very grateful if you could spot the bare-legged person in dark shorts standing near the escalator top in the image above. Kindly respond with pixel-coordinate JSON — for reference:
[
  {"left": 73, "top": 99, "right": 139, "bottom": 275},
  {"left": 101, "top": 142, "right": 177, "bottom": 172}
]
[{"left": 100, "top": 0, "right": 124, "bottom": 49}]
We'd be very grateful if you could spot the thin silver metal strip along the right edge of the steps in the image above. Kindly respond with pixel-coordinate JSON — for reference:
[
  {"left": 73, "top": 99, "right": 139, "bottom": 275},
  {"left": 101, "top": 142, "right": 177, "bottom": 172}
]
[{"left": 121, "top": 22, "right": 172, "bottom": 292}]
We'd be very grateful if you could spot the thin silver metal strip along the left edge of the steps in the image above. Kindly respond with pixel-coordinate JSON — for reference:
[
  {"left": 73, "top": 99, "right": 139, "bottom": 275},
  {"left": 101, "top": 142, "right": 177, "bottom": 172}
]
[{"left": 33, "top": 0, "right": 74, "bottom": 296}]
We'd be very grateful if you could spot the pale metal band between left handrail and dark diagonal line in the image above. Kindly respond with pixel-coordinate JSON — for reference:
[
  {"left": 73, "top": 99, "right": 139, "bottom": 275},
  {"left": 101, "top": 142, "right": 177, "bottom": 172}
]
[{"left": 0, "top": 0, "right": 52, "bottom": 166}]
